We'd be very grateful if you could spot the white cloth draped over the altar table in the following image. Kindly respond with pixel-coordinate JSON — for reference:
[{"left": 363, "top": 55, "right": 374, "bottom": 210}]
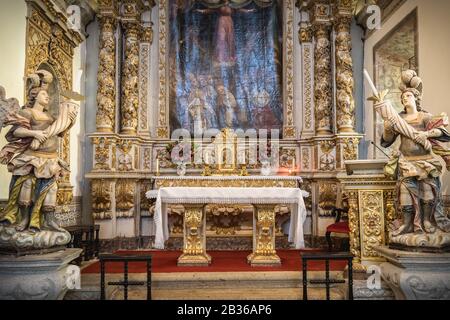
[{"left": 146, "top": 187, "right": 309, "bottom": 249}]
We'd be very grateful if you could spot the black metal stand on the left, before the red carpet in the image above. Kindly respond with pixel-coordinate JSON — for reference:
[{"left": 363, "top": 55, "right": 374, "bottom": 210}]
[{"left": 99, "top": 254, "right": 152, "bottom": 300}]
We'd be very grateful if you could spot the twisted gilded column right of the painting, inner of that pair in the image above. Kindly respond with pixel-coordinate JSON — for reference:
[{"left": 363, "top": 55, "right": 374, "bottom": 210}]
[{"left": 309, "top": 0, "right": 333, "bottom": 135}]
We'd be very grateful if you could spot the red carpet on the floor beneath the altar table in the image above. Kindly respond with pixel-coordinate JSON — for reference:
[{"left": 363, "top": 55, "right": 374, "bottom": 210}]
[{"left": 82, "top": 250, "right": 347, "bottom": 274}]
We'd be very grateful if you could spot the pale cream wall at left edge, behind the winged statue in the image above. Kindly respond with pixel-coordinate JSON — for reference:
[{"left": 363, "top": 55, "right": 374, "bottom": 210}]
[{"left": 0, "top": 0, "right": 27, "bottom": 199}]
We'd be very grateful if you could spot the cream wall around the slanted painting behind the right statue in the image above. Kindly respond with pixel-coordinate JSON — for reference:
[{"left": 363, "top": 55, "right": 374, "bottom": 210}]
[{"left": 364, "top": 0, "right": 450, "bottom": 194}]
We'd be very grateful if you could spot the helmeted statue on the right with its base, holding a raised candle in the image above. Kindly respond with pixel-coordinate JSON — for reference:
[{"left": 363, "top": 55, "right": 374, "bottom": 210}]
[{"left": 366, "top": 70, "right": 450, "bottom": 251}]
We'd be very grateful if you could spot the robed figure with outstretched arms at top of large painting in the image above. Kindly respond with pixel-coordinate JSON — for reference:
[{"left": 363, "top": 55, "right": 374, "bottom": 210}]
[{"left": 197, "top": 1, "right": 255, "bottom": 65}]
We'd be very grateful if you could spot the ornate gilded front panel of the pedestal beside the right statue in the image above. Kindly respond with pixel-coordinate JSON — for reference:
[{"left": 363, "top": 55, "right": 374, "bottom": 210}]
[{"left": 359, "top": 191, "right": 385, "bottom": 258}]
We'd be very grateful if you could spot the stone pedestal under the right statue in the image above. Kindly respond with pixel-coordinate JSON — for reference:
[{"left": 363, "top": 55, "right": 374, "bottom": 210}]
[{"left": 375, "top": 247, "right": 450, "bottom": 300}]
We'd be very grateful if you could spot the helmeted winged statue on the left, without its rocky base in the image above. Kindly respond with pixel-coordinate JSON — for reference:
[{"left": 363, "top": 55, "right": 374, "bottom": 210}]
[{"left": 0, "top": 70, "right": 78, "bottom": 240}]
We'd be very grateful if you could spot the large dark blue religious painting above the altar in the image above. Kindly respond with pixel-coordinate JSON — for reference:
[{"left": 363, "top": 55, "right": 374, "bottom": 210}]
[{"left": 169, "top": 0, "right": 283, "bottom": 134}]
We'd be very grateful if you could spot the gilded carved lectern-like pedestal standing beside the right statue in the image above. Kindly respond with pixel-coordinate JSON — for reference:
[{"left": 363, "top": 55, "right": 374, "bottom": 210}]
[{"left": 337, "top": 160, "right": 396, "bottom": 268}]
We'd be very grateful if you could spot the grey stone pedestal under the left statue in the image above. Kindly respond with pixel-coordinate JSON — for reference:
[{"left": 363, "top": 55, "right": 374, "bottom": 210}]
[{"left": 0, "top": 249, "right": 82, "bottom": 300}]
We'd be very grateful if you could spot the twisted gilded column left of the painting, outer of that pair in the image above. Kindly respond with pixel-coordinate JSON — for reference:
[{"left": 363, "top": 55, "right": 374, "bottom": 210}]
[{"left": 96, "top": 16, "right": 116, "bottom": 132}]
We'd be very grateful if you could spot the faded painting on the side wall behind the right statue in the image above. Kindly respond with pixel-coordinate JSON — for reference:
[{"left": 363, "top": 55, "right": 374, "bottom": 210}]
[{"left": 374, "top": 9, "right": 419, "bottom": 158}]
